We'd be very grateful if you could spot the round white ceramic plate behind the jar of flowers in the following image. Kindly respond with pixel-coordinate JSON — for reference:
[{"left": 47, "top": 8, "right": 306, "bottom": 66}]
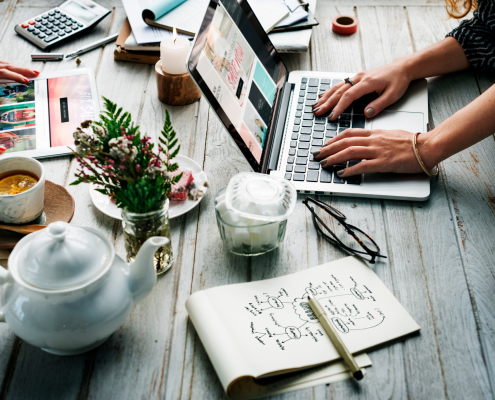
[{"left": 89, "top": 155, "right": 208, "bottom": 220}]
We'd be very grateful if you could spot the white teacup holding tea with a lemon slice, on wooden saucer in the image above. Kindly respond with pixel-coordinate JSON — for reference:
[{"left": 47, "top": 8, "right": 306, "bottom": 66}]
[{"left": 0, "top": 157, "right": 45, "bottom": 224}]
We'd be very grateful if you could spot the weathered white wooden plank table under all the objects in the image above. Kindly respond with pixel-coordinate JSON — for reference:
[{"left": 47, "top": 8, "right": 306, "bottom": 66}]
[{"left": 0, "top": 0, "right": 495, "bottom": 400}]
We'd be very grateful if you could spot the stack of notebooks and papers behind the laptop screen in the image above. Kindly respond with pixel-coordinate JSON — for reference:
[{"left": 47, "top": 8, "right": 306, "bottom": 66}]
[{"left": 114, "top": 0, "right": 318, "bottom": 64}]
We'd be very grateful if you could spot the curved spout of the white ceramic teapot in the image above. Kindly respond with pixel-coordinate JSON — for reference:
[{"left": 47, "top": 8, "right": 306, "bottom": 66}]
[{"left": 129, "top": 236, "right": 169, "bottom": 304}]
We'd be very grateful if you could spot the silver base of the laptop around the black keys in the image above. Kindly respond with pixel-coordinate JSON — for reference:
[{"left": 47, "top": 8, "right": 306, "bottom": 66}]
[{"left": 270, "top": 71, "right": 430, "bottom": 200}]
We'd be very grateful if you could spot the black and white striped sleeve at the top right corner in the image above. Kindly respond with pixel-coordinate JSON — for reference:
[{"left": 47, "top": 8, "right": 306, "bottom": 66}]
[{"left": 447, "top": 0, "right": 495, "bottom": 72}]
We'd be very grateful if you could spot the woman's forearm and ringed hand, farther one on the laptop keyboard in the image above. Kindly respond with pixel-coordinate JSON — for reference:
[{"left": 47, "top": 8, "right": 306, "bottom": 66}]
[{"left": 314, "top": 37, "right": 469, "bottom": 120}]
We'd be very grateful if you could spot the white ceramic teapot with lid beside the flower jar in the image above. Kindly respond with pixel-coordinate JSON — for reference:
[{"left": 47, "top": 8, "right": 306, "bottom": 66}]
[{"left": 0, "top": 222, "right": 168, "bottom": 355}]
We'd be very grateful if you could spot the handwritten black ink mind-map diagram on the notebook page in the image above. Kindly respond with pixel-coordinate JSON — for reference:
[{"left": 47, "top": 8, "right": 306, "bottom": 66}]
[{"left": 245, "top": 274, "right": 386, "bottom": 350}]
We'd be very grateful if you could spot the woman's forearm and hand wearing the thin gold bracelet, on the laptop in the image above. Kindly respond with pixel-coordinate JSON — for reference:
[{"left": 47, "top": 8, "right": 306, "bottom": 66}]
[{"left": 314, "top": 85, "right": 495, "bottom": 178}]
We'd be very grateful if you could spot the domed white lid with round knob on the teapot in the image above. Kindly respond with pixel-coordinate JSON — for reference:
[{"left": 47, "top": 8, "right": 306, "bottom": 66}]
[{"left": 19, "top": 221, "right": 112, "bottom": 290}]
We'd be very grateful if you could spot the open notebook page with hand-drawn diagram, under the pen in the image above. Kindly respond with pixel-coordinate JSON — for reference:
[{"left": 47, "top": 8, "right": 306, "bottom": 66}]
[{"left": 188, "top": 257, "right": 420, "bottom": 377}]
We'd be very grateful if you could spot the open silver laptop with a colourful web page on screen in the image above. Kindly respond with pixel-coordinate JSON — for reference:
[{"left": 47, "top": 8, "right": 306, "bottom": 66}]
[{"left": 187, "top": 0, "right": 430, "bottom": 200}]
